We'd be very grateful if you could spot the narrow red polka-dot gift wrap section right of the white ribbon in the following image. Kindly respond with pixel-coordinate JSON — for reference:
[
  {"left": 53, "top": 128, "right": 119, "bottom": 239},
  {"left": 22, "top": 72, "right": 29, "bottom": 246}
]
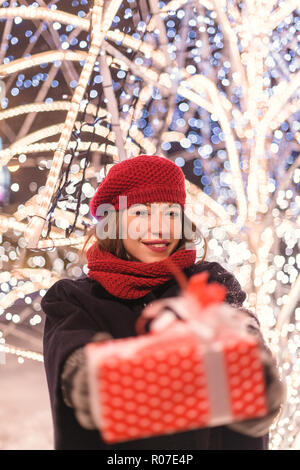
[{"left": 224, "top": 340, "right": 267, "bottom": 420}]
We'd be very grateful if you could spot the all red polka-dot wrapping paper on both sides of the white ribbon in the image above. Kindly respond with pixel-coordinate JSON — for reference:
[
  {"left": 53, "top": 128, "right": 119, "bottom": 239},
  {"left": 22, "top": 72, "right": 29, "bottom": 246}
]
[{"left": 90, "top": 332, "right": 267, "bottom": 443}]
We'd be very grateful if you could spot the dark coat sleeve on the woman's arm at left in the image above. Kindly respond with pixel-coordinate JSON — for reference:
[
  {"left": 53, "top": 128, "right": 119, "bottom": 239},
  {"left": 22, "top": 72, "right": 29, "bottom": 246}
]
[{"left": 41, "top": 279, "right": 105, "bottom": 422}]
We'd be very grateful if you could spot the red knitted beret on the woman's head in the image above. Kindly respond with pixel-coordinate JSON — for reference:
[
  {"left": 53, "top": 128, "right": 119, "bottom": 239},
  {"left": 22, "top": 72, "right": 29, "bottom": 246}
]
[{"left": 90, "top": 155, "right": 186, "bottom": 219}]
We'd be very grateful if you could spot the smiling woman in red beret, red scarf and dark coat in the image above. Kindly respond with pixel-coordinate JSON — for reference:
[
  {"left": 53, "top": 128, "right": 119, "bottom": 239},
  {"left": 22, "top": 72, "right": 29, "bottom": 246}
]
[{"left": 41, "top": 155, "right": 283, "bottom": 450}]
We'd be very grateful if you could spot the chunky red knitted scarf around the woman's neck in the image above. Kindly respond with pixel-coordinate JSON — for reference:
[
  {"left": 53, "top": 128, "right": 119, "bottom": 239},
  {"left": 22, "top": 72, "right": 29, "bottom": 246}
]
[{"left": 86, "top": 242, "right": 196, "bottom": 299}]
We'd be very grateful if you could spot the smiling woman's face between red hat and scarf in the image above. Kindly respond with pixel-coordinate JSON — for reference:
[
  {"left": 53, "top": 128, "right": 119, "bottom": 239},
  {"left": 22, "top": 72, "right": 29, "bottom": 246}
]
[{"left": 122, "top": 202, "right": 182, "bottom": 263}]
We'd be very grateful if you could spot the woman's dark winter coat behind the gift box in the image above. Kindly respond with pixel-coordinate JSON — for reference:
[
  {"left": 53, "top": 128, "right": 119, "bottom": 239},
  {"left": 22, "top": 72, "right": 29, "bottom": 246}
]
[{"left": 41, "top": 262, "right": 268, "bottom": 450}]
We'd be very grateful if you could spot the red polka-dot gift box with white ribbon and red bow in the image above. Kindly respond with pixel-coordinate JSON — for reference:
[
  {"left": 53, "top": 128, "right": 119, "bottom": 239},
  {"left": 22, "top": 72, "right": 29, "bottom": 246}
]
[{"left": 85, "top": 273, "right": 267, "bottom": 443}]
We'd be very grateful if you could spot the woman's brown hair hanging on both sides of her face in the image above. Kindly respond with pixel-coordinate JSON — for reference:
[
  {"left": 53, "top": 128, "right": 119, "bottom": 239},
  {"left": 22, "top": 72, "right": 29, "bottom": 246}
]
[{"left": 80, "top": 211, "right": 207, "bottom": 264}]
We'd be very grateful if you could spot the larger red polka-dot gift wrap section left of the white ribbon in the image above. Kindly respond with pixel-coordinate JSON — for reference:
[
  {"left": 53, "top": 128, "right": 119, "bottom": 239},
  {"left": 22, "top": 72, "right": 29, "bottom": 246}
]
[{"left": 98, "top": 337, "right": 210, "bottom": 443}]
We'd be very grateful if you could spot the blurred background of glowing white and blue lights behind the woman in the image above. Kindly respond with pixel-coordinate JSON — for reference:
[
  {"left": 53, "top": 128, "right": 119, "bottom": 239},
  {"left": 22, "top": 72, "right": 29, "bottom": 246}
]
[{"left": 0, "top": 0, "right": 300, "bottom": 450}]
